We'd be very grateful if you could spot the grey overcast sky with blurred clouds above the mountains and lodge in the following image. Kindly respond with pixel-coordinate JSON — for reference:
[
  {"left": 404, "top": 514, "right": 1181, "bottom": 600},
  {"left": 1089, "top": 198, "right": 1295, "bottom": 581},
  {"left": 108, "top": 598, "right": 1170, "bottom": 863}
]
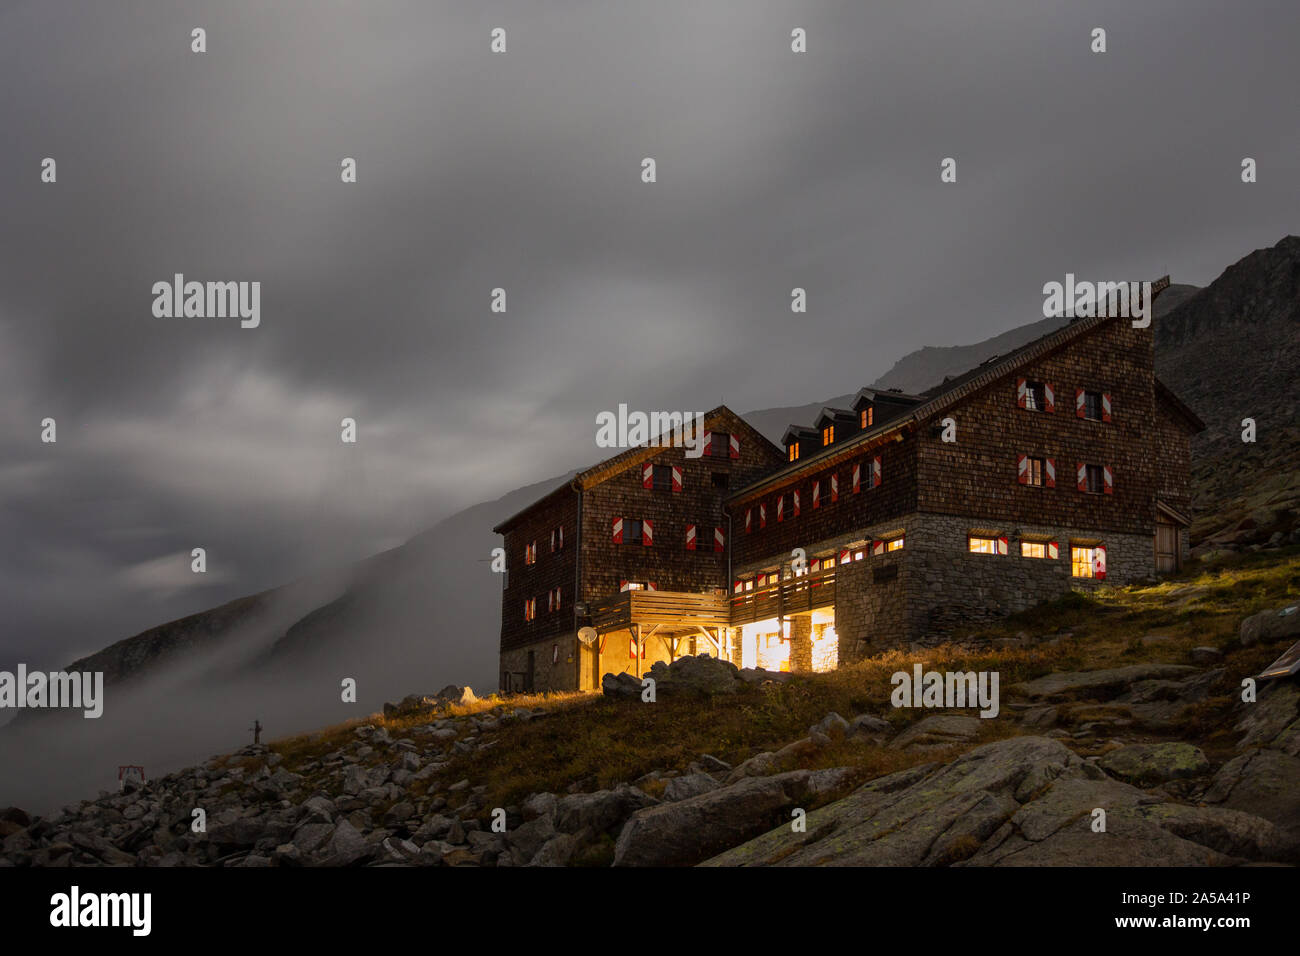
[{"left": 0, "top": 0, "right": 1300, "bottom": 667}]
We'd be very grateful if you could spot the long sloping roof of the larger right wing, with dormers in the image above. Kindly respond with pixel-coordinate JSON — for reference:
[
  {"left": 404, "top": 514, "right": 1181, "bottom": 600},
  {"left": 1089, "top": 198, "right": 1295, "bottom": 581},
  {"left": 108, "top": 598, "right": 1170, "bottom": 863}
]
[{"left": 727, "top": 276, "right": 1185, "bottom": 503}]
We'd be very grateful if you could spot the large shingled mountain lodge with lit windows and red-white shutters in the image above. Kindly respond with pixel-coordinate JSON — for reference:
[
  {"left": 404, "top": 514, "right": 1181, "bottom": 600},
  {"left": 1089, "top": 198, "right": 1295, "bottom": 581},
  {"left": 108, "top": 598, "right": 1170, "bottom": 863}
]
[{"left": 497, "top": 287, "right": 1204, "bottom": 691}]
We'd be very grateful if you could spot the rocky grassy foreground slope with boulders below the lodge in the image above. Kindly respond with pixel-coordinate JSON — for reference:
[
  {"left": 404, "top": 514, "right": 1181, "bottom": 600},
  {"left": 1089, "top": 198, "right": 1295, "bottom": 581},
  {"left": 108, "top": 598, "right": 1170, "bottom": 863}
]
[{"left": 0, "top": 554, "right": 1300, "bottom": 866}]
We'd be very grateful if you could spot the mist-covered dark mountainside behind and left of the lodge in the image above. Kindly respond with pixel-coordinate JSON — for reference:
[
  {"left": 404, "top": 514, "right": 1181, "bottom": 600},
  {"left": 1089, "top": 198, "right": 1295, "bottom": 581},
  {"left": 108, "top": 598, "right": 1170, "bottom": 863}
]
[{"left": 0, "top": 477, "right": 564, "bottom": 814}]
